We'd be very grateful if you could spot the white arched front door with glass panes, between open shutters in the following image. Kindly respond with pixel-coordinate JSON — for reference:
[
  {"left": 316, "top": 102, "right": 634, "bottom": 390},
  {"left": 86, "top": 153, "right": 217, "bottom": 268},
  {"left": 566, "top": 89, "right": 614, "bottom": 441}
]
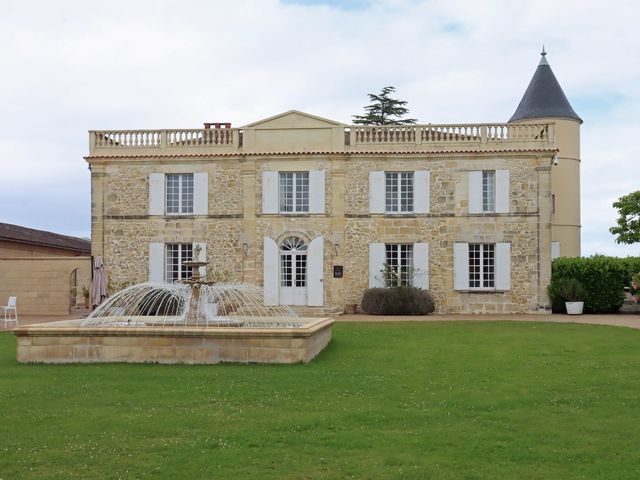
[{"left": 280, "top": 237, "right": 308, "bottom": 305}]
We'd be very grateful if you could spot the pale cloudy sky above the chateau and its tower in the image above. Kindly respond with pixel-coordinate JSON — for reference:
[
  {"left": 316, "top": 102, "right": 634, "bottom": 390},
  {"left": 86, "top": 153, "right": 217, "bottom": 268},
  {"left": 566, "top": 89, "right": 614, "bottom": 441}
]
[{"left": 0, "top": 0, "right": 640, "bottom": 256}]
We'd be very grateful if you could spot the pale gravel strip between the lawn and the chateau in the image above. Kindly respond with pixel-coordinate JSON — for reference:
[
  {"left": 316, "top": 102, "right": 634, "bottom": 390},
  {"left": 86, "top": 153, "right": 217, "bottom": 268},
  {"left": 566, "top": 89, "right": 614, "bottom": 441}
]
[{"left": 0, "top": 313, "right": 640, "bottom": 331}]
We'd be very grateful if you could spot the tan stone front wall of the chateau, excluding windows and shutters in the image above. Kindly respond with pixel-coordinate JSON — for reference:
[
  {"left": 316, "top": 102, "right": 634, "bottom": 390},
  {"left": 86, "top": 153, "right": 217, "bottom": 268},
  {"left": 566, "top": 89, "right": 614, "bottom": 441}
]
[{"left": 87, "top": 111, "right": 568, "bottom": 315}]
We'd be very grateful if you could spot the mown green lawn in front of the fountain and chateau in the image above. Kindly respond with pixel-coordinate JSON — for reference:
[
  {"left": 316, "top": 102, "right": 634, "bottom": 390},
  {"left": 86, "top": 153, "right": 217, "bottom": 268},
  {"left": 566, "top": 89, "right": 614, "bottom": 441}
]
[{"left": 0, "top": 322, "right": 640, "bottom": 480}]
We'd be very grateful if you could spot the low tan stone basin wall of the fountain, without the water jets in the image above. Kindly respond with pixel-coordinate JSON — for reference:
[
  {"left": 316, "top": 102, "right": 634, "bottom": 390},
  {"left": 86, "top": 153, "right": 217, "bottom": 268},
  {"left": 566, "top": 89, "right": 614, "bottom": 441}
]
[{"left": 13, "top": 318, "right": 334, "bottom": 364}]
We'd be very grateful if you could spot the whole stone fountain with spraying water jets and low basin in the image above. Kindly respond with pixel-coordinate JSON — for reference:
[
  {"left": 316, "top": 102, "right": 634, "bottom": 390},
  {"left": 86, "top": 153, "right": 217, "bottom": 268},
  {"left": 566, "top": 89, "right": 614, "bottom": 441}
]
[{"left": 13, "top": 252, "right": 333, "bottom": 363}]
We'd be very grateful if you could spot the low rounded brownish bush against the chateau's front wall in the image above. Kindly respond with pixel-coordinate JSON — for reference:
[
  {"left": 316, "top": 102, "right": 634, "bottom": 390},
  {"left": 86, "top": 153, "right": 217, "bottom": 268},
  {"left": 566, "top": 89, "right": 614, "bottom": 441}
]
[{"left": 360, "top": 287, "right": 435, "bottom": 315}]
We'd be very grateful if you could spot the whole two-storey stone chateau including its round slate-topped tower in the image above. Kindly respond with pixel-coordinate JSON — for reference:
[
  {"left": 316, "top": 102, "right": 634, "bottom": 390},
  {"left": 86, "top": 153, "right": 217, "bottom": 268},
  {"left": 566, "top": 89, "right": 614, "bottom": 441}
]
[{"left": 86, "top": 52, "right": 582, "bottom": 314}]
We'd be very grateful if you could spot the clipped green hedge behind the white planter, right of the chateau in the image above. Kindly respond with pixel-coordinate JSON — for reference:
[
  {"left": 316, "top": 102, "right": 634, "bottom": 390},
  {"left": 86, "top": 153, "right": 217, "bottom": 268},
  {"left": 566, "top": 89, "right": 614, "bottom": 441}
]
[{"left": 551, "top": 255, "right": 640, "bottom": 313}]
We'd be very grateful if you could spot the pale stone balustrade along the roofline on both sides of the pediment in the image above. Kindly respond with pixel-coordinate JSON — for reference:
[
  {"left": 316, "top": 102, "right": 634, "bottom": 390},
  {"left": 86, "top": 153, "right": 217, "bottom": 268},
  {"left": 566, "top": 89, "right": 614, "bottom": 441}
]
[{"left": 89, "top": 123, "right": 555, "bottom": 155}]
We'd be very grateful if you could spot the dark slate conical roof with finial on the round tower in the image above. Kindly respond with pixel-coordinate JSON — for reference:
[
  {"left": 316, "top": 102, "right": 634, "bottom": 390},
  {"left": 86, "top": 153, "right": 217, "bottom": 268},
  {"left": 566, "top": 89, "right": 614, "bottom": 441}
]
[{"left": 509, "top": 48, "right": 582, "bottom": 123}]
